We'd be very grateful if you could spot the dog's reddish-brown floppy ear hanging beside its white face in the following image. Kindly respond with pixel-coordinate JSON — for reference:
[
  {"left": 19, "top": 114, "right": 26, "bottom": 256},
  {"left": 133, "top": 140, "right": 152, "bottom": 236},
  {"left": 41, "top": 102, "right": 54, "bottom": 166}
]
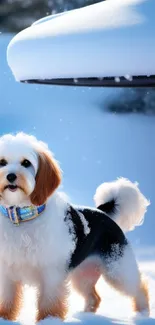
[{"left": 30, "top": 152, "right": 61, "bottom": 205}]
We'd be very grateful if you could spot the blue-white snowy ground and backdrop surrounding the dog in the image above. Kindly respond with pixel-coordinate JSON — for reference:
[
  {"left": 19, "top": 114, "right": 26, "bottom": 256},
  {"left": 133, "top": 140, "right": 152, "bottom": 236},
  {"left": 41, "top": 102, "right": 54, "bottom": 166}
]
[{"left": 0, "top": 34, "right": 155, "bottom": 325}]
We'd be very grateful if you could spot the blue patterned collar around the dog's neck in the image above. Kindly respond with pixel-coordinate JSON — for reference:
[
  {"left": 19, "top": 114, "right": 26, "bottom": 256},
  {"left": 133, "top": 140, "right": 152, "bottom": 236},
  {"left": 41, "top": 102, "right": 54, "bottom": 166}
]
[{"left": 0, "top": 204, "right": 46, "bottom": 226}]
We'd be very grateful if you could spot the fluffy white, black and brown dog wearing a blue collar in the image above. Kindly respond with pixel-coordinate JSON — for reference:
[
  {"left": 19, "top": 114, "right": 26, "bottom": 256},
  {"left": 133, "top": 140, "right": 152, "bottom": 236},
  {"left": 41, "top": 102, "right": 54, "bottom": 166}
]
[{"left": 0, "top": 133, "right": 149, "bottom": 321}]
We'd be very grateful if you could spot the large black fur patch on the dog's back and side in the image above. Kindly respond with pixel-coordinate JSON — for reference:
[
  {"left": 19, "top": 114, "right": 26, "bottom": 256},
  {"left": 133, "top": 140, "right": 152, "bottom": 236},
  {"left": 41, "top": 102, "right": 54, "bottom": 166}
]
[{"left": 67, "top": 206, "right": 128, "bottom": 269}]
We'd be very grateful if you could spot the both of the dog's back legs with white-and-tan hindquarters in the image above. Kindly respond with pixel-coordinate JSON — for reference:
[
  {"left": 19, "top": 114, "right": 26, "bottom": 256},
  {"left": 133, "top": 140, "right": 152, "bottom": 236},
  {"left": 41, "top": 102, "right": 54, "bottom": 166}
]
[{"left": 71, "top": 244, "right": 149, "bottom": 315}]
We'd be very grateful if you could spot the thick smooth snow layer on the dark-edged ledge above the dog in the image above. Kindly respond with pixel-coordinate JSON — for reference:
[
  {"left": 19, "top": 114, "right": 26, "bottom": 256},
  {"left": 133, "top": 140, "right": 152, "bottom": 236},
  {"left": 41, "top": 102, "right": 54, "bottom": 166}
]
[{"left": 7, "top": 0, "right": 155, "bottom": 80}]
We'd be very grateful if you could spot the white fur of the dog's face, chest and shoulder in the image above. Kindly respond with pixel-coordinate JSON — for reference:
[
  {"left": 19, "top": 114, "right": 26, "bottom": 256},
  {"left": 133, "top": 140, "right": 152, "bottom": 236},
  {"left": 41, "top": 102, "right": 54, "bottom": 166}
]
[{"left": 0, "top": 133, "right": 76, "bottom": 299}]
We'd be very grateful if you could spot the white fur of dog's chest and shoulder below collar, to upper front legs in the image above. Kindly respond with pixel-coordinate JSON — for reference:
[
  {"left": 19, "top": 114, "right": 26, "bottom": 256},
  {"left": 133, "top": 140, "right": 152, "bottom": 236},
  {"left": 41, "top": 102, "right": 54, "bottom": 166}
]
[{"left": 0, "top": 193, "right": 76, "bottom": 306}]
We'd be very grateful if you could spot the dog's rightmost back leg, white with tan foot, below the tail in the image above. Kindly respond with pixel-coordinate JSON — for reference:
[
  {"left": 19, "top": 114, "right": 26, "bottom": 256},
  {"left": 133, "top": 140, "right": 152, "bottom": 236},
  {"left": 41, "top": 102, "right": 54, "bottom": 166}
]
[{"left": 102, "top": 244, "right": 149, "bottom": 315}]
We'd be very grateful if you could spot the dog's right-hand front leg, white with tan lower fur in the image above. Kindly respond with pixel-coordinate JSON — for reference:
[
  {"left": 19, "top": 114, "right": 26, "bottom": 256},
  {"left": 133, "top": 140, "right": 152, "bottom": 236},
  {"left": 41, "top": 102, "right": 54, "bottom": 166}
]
[{"left": 37, "top": 271, "right": 68, "bottom": 321}]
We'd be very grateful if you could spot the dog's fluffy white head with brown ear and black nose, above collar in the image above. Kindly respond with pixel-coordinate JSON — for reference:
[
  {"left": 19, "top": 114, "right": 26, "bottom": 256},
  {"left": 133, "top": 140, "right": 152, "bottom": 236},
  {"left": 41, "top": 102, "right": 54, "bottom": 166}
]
[{"left": 0, "top": 133, "right": 61, "bottom": 206}]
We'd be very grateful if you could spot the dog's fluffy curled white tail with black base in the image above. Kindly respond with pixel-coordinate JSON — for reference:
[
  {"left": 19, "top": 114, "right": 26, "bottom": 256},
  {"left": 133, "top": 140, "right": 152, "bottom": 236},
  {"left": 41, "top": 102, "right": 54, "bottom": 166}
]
[{"left": 94, "top": 178, "right": 150, "bottom": 232}]
